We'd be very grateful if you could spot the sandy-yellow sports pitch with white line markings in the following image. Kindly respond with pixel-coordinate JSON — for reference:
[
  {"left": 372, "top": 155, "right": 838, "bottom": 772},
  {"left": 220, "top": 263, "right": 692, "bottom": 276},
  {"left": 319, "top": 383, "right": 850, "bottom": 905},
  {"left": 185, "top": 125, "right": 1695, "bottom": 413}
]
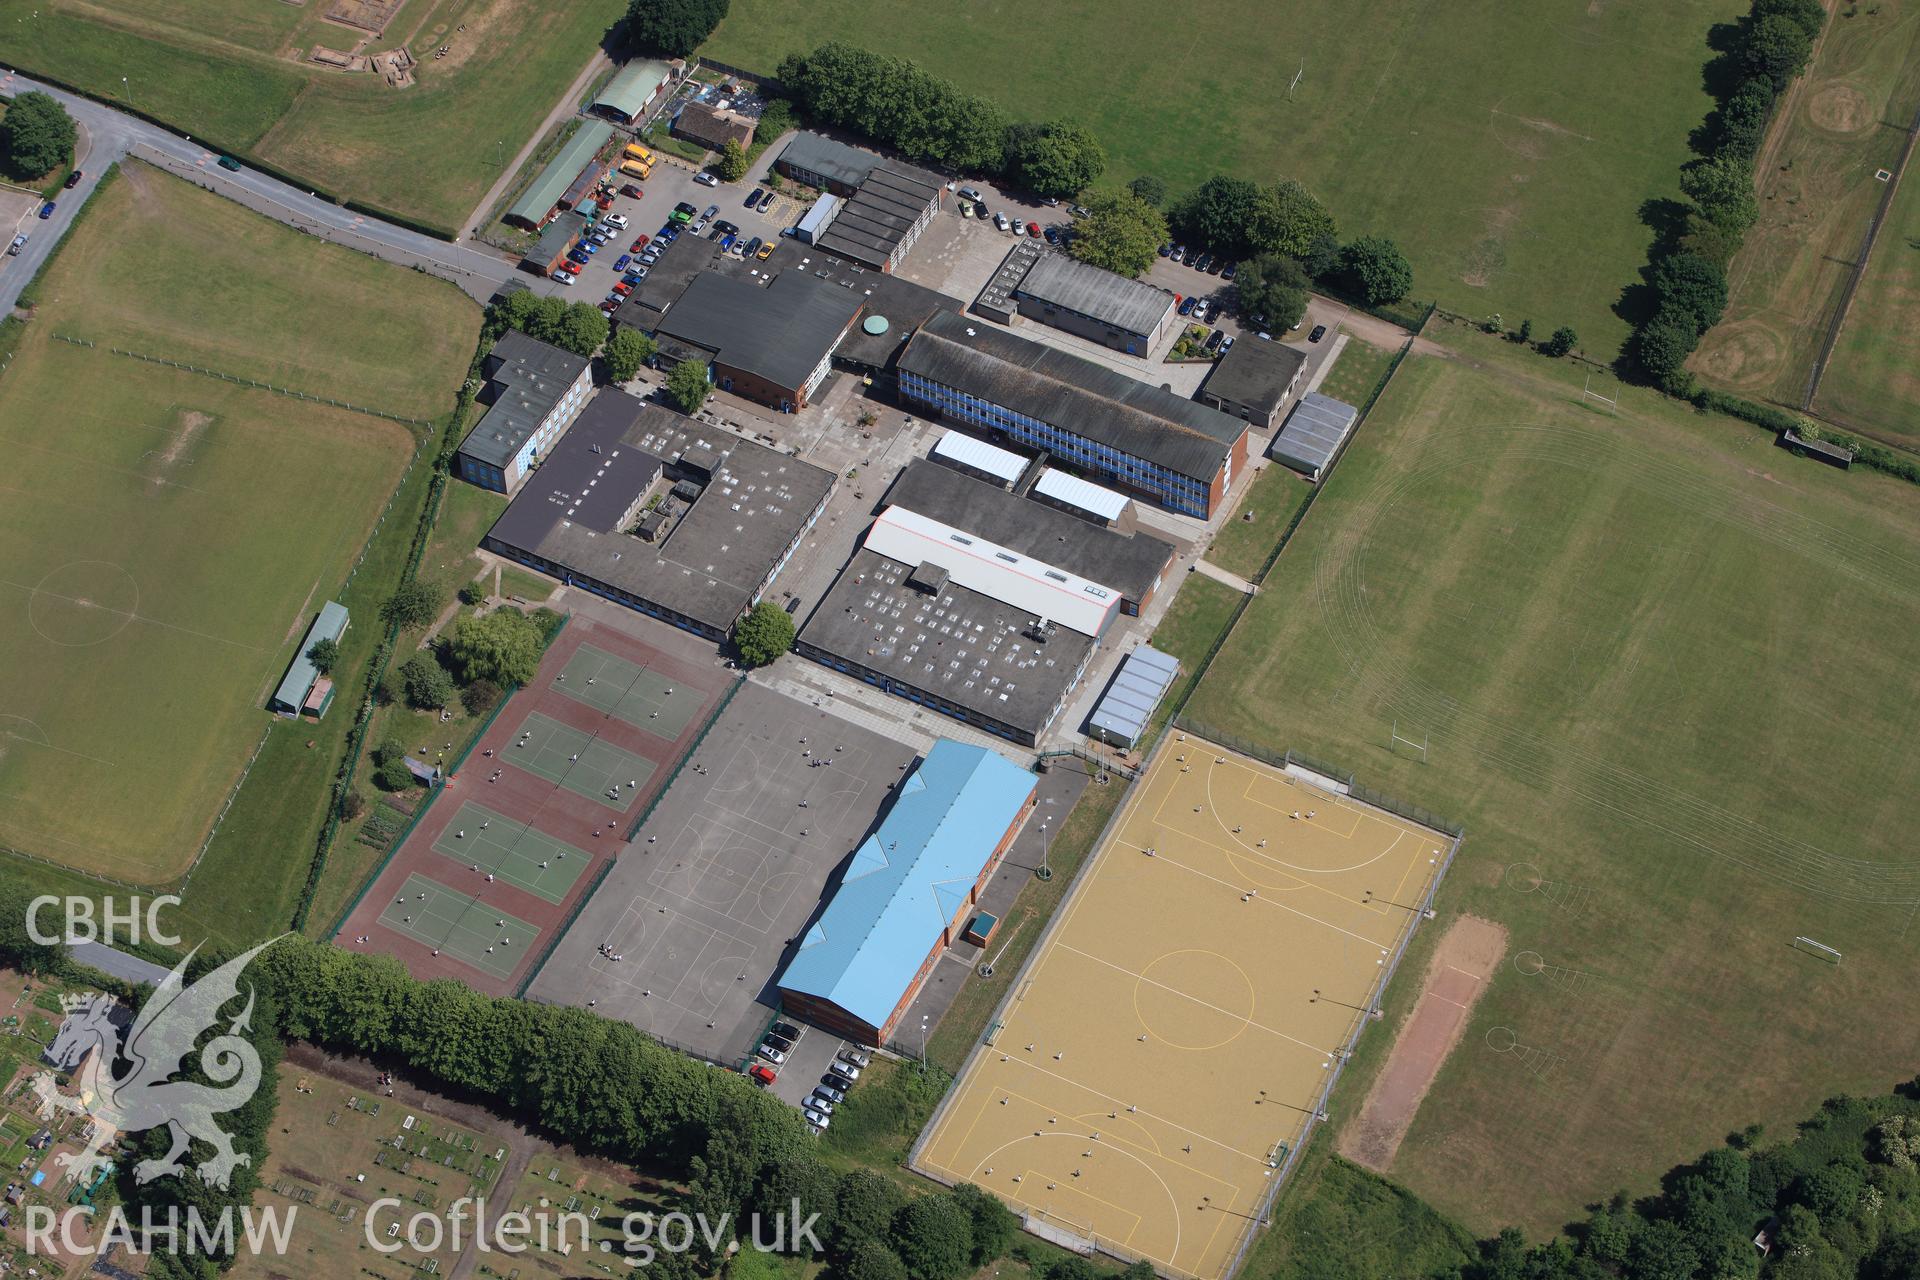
[{"left": 914, "top": 733, "right": 1448, "bottom": 1280}]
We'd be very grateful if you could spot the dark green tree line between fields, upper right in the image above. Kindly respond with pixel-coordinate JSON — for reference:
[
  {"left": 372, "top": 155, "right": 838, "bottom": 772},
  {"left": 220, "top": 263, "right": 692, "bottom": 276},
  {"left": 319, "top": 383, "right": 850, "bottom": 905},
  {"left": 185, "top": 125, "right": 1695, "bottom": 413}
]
[{"left": 1630, "top": 0, "right": 1826, "bottom": 399}]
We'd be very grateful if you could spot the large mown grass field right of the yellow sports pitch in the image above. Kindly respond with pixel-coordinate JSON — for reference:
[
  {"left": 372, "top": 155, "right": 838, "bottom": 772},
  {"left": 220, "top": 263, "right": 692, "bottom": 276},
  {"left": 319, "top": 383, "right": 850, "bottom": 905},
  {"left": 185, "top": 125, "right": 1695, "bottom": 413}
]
[{"left": 1188, "top": 328, "right": 1920, "bottom": 1230}]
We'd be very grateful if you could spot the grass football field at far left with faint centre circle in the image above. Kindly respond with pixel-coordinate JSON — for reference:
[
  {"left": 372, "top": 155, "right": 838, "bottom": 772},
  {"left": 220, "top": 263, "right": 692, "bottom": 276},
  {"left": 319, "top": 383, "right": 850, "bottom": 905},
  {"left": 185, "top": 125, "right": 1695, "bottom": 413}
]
[{"left": 0, "top": 165, "right": 476, "bottom": 890}]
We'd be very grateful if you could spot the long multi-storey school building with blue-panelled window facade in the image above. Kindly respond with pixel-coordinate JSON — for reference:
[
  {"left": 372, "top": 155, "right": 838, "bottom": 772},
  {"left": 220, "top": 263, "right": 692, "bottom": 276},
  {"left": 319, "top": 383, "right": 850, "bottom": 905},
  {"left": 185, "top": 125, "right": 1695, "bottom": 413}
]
[{"left": 899, "top": 311, "right": 1246, "bottom": 520}]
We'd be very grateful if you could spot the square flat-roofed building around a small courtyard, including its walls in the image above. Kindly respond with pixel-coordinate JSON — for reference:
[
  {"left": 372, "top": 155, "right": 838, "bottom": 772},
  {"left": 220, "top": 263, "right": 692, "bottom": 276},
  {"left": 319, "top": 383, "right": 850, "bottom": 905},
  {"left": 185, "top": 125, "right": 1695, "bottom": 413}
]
[{"left": 482, "top": 388, "right": 833, "bottom": 641}]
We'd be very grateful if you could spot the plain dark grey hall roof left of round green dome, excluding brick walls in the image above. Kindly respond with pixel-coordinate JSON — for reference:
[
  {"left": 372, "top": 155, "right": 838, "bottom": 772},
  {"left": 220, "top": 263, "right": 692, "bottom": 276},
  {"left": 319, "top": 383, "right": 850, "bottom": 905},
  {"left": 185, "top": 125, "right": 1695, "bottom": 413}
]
[{"left": 657, "top": 271, "right": 864, "bottom": 388}]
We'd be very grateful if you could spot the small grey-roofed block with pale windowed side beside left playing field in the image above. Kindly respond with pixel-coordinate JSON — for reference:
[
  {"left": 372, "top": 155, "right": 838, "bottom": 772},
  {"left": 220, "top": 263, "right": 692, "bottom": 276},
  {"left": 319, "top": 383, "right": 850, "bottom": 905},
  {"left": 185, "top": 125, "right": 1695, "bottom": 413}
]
[{"left": 453, "top": 328, "right": 593, "bottom": 493}]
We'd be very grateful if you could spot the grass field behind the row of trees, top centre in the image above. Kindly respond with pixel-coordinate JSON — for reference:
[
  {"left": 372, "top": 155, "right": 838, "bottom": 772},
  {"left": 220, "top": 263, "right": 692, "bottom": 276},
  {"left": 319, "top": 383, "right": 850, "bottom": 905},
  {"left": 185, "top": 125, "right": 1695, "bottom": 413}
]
[{"left": 703, "top": 0, "right": 1745, "bottom": 355}]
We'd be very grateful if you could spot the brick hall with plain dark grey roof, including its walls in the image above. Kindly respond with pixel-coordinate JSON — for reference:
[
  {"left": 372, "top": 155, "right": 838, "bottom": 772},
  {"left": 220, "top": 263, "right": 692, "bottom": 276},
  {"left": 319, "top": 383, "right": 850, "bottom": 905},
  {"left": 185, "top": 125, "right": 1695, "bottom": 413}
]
[{"left": 655, "top": 271, "right": 862, "bottom": 413}]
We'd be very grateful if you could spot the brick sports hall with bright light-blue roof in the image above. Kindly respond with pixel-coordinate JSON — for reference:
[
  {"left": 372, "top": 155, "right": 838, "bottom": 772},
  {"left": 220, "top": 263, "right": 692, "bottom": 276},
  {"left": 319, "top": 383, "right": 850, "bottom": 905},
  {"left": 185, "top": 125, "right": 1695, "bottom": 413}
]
[{"left": 780, "top": 739, "right": 1035, "bottom": 1044}]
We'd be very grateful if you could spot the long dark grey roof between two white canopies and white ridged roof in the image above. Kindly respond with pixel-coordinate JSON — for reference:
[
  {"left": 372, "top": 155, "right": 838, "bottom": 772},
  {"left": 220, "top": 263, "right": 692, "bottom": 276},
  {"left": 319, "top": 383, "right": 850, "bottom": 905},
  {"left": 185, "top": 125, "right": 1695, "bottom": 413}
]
[{"left": 883, "top": 459, "right": 1173, "bottom": 601}]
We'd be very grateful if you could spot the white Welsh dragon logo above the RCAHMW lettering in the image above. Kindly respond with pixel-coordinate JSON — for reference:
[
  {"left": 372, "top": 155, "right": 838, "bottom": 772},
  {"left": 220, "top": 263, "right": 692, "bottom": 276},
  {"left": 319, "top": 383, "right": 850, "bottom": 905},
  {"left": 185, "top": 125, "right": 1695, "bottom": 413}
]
[{"left": 33, "top": 938, "right": 278, "bottom": 1190}]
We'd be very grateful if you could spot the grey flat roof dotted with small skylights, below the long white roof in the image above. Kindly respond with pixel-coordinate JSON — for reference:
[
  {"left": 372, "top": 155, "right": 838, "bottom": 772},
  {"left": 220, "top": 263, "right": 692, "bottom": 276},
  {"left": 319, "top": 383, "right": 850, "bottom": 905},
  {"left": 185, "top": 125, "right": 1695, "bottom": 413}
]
[{"left": 801, "top": 547, "right": 1094, "bottom": 735}]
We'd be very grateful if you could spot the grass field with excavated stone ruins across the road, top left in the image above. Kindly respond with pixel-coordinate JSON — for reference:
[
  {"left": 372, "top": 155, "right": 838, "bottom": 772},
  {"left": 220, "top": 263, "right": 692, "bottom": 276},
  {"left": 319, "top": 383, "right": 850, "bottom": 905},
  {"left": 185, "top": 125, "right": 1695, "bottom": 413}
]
[{"left": 0, "top": 0, "right": 624, "bottom": 230}]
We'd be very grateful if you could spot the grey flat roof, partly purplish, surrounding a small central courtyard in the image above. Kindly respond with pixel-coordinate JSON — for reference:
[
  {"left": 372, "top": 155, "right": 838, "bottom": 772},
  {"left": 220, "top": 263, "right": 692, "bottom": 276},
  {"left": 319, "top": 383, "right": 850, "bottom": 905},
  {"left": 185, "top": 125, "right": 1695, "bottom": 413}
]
[{"left": 486, "top": 388, "right": 833, "bottom": 631}]
